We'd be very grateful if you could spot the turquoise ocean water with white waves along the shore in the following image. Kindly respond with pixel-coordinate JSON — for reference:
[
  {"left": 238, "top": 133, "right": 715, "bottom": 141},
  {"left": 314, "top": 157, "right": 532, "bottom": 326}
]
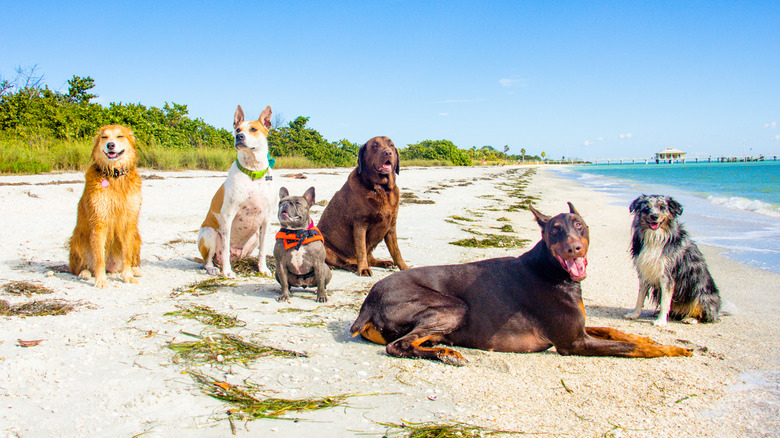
[{"left": 549, "top": 161, "right": 780, "bottom": 273}]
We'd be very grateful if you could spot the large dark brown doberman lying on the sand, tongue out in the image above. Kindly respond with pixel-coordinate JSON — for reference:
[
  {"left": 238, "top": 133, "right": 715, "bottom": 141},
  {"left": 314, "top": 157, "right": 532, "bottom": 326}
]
[{"left": 351, "top": 203, "right": 691, "bottom": 365}]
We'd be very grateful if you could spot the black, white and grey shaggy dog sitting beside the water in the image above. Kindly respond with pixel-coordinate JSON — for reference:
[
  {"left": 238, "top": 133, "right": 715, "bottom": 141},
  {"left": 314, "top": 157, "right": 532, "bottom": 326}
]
[{"left": 625, "top": 195, "right": 721, "bottom": 326}]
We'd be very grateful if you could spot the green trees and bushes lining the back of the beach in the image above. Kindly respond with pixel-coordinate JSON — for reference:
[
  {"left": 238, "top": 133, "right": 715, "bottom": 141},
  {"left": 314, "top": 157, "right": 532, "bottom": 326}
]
[{"left": 0, "top": 67, "right": 538, "bottom": 167}]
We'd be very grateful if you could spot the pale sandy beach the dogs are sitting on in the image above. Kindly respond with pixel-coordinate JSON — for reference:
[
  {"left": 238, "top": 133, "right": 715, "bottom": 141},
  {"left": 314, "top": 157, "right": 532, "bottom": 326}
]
[{"left": 0, "top": 166, "right": 780, "bottom": 437}]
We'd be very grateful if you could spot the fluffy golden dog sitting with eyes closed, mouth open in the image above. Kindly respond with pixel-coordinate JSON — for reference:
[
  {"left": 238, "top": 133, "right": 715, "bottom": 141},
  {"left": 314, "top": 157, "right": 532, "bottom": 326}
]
[{"left": 68, "top": 125, "right": 141, "bottom": 288}]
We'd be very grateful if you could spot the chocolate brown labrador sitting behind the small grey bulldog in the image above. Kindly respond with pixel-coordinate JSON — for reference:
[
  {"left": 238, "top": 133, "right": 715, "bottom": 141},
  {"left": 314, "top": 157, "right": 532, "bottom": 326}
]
[{"left": 317, "top": 137, "right": 408, "bottom": 276}]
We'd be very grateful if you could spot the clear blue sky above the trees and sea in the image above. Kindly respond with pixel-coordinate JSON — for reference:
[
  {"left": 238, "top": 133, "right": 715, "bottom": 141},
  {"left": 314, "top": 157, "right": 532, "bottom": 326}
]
[{"left": 0, "top": 0, "right": 780, "bottom": 159}]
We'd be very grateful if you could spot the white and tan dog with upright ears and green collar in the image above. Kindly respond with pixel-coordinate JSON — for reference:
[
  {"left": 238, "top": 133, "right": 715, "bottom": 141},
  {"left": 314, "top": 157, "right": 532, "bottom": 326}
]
[{"left": 198, "top": 105, "right": 276, "bottom": 278}]
